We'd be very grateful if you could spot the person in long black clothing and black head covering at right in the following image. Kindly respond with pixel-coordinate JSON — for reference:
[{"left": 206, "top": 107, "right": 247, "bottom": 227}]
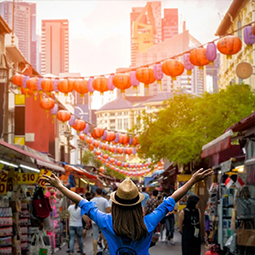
[{"left": 179, "top": 195, "right": 201, "bottom": 255}]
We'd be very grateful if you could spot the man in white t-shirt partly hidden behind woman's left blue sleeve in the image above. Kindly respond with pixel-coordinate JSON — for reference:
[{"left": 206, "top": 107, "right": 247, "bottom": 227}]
[{"left": 90, "top": 188, "right": 111, "bottom": 255}]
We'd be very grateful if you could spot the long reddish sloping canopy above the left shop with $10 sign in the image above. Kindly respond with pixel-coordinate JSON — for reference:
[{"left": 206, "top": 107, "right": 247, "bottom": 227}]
[{"left": 0, "top": 140, "right": 65, "bottom": 173}]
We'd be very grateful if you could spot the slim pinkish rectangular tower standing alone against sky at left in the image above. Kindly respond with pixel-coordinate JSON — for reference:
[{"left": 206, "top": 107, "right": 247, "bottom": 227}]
[{"left": 41, "top": 19, "right": 69, "bottom": 76}]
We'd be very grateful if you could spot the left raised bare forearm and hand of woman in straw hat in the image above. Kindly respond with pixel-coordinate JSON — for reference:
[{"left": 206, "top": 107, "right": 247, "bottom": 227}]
[{"left": 43, "top": 174, "right": 83, "bottom": 204}]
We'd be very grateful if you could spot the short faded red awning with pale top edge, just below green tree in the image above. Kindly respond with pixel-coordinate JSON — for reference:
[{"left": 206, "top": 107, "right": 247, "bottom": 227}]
[{"left": 201, "top": 130, "right": 233, "bottom": 158}]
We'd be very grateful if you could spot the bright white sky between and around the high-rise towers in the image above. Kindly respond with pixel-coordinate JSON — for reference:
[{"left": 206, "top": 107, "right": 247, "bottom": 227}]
[{"left": 24, "top": 0, "right": 232, "bottom": 108}]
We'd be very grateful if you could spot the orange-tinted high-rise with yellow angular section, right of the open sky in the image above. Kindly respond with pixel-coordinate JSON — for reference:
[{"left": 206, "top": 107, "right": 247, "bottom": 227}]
[{"left": 130, "top": 1, "right": 178, "bottom": 67}]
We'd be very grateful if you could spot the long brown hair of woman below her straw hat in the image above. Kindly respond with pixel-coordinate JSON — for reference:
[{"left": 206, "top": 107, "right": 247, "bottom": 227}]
[{"left": 112, "top": 203, "right": 148, "bottom": 241}]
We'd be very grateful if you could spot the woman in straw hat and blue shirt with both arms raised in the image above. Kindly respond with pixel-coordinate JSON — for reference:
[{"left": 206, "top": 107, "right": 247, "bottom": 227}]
[{"left": 43, "top": 169, "right": 212, "bottom": 255}]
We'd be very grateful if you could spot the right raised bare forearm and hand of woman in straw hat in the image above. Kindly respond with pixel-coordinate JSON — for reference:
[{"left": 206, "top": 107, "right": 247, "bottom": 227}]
[{"left": 171, "top": 168, "right": 213, "bottom": 202}]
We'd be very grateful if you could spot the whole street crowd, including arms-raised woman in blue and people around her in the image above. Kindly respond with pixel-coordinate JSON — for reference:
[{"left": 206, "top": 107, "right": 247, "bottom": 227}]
[{"left": 46, "top": 167, "right": 211, "bottom": 255}]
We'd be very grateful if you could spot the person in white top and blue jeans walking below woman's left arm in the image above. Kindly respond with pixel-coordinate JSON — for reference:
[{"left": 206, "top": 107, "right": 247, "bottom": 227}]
[{"left": 68, "top": 203, "right": 86, "bottom": 255}]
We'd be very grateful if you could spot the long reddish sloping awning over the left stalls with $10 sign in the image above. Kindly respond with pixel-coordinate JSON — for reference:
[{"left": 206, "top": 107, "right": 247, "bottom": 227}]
[{"left": 0, "top": 140, "right": 65, "bottom": 173}]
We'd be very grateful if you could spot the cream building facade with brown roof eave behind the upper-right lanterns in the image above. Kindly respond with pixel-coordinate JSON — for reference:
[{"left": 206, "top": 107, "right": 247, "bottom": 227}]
[{"left": 215, "top": 0, "right": 255, "bottom": 89}]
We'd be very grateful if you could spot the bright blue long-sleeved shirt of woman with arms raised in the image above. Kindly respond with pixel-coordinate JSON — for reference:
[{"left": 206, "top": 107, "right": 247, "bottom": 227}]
[{"left": 79, "top": 197, "right": 175, "bottom": 255}]
